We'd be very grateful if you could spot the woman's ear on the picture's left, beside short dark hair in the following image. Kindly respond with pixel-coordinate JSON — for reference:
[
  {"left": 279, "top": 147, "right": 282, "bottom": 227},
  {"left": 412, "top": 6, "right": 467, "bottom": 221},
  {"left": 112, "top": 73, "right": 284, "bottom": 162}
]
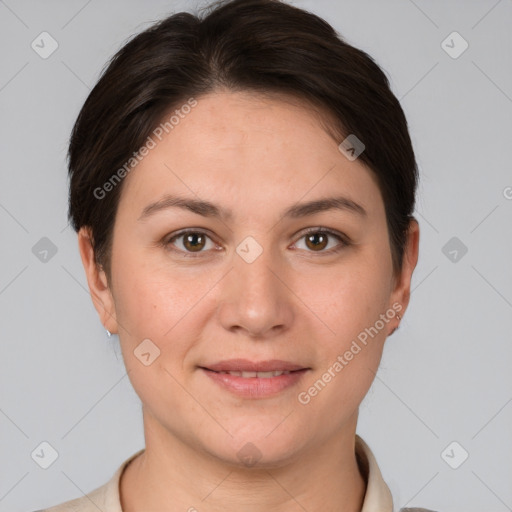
[{"left": 78, "top": 227, "right": 117, "bottom": 334}]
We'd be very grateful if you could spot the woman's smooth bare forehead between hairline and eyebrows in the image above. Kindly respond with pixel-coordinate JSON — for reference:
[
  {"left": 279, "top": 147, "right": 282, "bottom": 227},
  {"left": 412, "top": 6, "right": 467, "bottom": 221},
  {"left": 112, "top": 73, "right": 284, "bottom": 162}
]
[{"left": 115, "top": 92, "right": 380, "bottom": 220}]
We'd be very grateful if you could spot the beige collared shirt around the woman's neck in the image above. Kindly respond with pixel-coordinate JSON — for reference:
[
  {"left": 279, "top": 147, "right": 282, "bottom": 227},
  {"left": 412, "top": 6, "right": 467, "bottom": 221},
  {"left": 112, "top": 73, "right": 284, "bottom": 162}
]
[{"left": 36, "top": 435, "right": 404, "bottom": 512}]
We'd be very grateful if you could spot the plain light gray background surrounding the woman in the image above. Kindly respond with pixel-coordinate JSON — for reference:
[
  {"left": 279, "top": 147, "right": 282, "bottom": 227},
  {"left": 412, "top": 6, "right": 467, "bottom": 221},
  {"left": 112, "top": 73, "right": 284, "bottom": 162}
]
[{"left": 0, "top": 0, "right": 512, "bottom": 512}]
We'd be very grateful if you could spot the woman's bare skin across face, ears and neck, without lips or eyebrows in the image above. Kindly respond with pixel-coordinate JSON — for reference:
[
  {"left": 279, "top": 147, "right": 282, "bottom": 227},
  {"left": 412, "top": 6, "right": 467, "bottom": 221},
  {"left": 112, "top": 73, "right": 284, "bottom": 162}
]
[{"left": 79, "top": 91, "right": 419, "bottom": 512}]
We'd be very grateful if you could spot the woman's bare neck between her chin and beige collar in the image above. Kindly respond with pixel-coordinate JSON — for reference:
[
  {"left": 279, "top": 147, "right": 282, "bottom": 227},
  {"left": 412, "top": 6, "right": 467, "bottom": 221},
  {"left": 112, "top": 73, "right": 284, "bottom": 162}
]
[{"left": 120, "top": 415, "right": 366, "bottom": 512}]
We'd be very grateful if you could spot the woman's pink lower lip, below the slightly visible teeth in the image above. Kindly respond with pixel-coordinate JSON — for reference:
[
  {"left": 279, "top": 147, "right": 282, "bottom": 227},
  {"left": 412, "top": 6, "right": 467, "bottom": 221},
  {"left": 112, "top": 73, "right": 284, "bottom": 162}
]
[{"left": 201, "top": 368, "right": 308, "bottom": 398}]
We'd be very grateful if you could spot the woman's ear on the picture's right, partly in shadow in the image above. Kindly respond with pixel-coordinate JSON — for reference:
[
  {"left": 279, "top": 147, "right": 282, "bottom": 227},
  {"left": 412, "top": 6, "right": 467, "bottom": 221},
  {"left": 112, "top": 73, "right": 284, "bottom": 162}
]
[{"left": 388, "top": 218, "right": 420, "bottom": 335}]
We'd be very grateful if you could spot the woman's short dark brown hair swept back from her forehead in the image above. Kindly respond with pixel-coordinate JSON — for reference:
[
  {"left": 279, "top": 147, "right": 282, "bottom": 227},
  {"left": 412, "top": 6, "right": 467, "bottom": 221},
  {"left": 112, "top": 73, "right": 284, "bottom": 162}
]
[{"left": 68, "top": 0, "right": 418, "bottom": 276}]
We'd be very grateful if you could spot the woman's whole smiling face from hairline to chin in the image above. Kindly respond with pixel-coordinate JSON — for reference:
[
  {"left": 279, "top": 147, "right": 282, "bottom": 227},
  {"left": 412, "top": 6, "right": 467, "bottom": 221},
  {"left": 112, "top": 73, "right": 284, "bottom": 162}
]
[{"left": 81, "top": 92, "right": 417, "bottom": 463}]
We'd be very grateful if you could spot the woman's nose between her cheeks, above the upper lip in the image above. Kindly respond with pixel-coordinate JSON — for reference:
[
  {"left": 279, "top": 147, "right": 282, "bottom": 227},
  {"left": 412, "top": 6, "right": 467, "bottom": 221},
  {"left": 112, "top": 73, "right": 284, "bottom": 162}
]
[{"left": 217, "top": 244, "right": 295, "bottom": 339}]
